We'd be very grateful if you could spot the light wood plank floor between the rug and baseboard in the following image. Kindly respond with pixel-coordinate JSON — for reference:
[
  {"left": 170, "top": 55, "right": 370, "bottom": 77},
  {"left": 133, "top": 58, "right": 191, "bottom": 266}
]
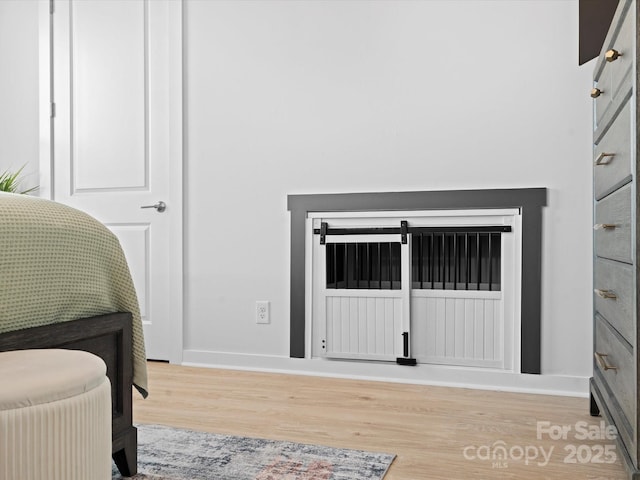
[{"left": 134, "top": 363, "right": 626, "bottom": 480}]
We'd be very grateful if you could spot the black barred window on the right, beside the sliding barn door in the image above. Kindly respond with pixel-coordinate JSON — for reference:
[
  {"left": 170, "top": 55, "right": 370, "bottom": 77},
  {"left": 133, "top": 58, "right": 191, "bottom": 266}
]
[{"left": 411, "top": 232, "right": 501, "bottom": 290}]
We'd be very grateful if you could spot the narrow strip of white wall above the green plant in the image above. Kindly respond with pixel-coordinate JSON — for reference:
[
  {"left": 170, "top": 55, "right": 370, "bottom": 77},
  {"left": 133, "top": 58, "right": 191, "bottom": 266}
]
[{"left": 0, "top": 0, "right": 40, "bottom": 188}]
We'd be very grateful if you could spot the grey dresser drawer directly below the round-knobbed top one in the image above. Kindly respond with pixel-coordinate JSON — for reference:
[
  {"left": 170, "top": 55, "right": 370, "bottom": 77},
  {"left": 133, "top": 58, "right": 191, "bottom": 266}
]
[{"left": 593, "top": 101, "right": 631, "bottom": 200}]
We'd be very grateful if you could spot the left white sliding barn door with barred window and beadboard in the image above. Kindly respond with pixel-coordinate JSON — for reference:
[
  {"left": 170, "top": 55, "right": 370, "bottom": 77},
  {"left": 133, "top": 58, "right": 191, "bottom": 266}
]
[{"left": 318, "top": 235, "right": 411, "bottom": 361}]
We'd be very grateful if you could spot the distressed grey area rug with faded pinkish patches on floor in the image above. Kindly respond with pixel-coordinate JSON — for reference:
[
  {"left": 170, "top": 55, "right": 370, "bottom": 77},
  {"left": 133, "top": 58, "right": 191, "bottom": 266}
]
[{"left": 113, "top": 425, "right": 395, "bottom": 480}]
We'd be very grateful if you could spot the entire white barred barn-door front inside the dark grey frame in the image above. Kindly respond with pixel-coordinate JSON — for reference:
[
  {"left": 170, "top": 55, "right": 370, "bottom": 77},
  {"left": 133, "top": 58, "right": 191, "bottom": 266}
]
[{"left": 308, "top": 210, "right": 521, "bottom": 372}]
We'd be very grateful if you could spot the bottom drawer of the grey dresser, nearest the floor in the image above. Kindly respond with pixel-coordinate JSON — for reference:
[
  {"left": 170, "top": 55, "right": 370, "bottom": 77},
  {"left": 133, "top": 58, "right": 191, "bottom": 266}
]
[{"left": 594, "top": 315, "right": 636, "bottom": 428}]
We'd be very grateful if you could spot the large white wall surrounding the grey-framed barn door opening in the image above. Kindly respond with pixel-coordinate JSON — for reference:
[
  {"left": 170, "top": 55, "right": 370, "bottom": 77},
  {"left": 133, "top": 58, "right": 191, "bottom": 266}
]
[{"left": 185, "top": 0, "right": 593, "bottom": 390}]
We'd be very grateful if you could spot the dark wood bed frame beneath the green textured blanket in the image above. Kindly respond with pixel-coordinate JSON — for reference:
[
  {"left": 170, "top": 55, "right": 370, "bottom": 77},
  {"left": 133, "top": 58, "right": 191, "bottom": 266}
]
[{"left": 0, "top": 313, "right": 138, "bottom": 477}]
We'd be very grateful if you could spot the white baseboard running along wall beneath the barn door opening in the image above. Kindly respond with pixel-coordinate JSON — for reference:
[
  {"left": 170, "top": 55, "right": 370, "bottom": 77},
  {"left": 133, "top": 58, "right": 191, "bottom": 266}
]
[{"left": 182, "top": 350, "right": 589, "bottom": 397}]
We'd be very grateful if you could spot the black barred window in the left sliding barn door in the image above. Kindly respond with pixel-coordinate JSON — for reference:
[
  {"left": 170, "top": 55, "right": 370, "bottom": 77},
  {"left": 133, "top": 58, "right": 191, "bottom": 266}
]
[{"left": 326, "top": 242, "right": 401, "bottom": 290}]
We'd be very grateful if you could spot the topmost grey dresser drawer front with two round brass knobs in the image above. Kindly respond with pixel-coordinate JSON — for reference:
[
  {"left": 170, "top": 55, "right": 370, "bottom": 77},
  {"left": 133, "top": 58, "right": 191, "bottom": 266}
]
[{"left": 594, "top": 5, "right": 635, "bottom": 125}]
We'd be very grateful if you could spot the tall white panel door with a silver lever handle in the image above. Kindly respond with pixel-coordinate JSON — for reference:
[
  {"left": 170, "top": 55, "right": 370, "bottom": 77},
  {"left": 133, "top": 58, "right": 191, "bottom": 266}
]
[{"left": 52, "top": 0, "right": 182, "bottom": 362}]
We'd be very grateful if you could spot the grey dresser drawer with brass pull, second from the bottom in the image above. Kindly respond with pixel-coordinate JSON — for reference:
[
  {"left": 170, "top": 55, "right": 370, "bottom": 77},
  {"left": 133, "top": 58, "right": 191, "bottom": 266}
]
[{"left": 593, "top": 258, "right": 635, "bottom": 345}]
